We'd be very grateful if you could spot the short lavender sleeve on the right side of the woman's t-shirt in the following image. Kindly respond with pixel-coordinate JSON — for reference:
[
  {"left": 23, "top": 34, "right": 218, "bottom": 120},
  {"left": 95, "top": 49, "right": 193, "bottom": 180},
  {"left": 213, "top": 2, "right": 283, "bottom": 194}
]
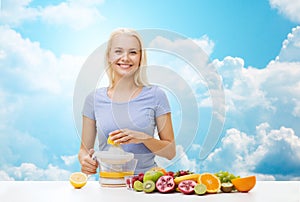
[{"left": 155, "top": 87, "right": 171, "bottom": 118}]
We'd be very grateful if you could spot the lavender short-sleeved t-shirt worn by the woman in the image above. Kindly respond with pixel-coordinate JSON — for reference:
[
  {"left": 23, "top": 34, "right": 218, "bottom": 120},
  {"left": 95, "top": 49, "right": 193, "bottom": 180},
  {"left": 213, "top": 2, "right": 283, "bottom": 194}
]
[{"left": 83, "top": 86, "right": 171, "bottom": 173}]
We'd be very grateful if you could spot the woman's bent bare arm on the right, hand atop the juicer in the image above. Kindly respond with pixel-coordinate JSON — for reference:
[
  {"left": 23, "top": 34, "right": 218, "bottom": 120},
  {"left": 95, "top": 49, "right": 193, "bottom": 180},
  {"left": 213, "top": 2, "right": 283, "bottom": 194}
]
[{"left": 109, "top": 113, "right": 176, "bottom": 160}]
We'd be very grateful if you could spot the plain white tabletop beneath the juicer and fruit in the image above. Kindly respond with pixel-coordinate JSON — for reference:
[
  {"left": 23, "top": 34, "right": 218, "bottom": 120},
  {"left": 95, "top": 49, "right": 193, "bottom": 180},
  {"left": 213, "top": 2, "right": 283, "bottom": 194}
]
[{"left": 0, "top": 181, "right": 300, "bottom": 202}]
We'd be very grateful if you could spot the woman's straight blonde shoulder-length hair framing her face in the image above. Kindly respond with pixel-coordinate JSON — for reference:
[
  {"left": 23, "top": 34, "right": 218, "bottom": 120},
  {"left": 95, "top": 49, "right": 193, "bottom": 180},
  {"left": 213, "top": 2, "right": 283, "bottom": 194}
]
[{"left": 105, "top": 28, "right": 148, "bottom": 87}]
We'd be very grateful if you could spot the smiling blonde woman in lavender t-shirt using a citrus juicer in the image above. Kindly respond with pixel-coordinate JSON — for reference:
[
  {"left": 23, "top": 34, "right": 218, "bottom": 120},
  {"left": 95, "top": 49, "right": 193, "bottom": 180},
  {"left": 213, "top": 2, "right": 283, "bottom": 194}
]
[{"left": 78, "top": 29, "right": 175, "bottom": 174}]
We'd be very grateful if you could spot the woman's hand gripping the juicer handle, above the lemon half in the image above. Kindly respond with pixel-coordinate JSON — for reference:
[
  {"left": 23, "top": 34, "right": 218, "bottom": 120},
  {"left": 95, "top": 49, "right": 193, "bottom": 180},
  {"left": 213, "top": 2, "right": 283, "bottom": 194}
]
[{"left": 80, "top": 149, "right": 98, "bottom": 175}]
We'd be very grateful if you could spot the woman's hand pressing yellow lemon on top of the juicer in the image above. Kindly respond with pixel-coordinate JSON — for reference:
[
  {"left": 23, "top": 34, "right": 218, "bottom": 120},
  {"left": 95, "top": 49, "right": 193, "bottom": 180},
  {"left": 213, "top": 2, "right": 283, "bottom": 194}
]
[{"left": 109, "top": 128, "right": 151, "bottom": 144}]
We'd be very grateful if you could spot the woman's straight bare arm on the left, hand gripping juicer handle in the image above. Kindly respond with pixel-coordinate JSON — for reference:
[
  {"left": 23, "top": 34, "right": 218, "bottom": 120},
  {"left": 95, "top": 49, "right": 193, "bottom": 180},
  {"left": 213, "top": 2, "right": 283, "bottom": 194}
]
[{"left": 78, "top": 116, "right": 98, "bottom": 174}]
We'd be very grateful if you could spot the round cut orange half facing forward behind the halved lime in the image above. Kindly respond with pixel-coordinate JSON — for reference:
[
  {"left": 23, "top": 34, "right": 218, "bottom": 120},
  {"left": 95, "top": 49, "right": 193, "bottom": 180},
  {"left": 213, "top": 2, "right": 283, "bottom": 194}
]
[{"left": 198, "top": 173, "right": 221, "bottom": 194}]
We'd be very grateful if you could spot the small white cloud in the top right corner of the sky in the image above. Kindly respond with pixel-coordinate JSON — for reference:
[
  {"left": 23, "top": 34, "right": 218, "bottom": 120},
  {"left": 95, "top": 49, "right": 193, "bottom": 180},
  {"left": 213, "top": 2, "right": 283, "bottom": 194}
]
[{"left": 269, "top": 0, "right": 300, "bottom": 23}]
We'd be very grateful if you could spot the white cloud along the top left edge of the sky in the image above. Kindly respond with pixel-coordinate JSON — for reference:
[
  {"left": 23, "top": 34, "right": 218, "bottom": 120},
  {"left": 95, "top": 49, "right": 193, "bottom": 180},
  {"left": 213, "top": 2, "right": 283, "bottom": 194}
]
[{"left": 0, "top": 0, "right": 104, "bottom": 30}]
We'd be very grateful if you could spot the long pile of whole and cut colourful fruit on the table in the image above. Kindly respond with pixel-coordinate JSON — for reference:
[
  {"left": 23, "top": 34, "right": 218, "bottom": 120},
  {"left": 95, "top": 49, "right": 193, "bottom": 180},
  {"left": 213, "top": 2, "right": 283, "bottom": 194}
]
[{"left": 126, "top": 167, "right": 256, "bottom": 195}]
